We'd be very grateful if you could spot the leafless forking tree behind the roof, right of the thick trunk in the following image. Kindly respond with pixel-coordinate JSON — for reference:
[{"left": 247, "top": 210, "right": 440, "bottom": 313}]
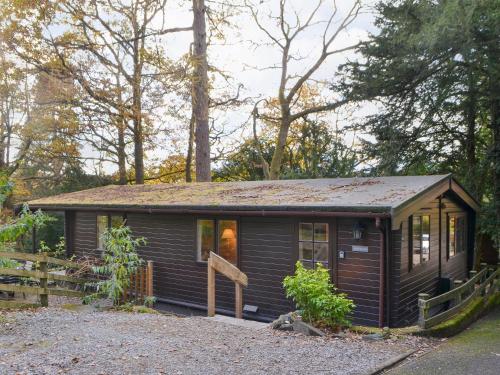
[{"left": 246, "top": 0, "right": 361, "bottom": 179}]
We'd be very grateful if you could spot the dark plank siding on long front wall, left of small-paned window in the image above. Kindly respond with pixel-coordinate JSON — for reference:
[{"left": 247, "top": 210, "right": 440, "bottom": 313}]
[{"left": 79, "top": 213, "right": 296, "bottom": 318}]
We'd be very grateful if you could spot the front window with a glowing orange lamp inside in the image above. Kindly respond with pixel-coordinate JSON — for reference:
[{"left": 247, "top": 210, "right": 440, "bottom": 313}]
[{"left": 196, "top": 219, "right": 238, "bottom": 265}]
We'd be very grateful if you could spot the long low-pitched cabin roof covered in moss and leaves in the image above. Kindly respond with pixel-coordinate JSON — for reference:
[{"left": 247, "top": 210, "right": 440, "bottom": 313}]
[{"left": 28, "top": 175, "right": 450, "bottom": 211}]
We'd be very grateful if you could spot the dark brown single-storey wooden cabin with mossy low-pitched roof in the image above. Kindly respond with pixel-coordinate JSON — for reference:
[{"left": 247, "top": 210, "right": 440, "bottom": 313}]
[{"left": 25, "top": 175, "right": 478, "bottom": 327}]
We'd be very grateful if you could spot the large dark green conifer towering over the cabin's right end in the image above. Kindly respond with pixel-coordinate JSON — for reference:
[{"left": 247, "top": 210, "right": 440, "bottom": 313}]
[{"left": 343, "top": 0, "right": 500, "bottom": 250}]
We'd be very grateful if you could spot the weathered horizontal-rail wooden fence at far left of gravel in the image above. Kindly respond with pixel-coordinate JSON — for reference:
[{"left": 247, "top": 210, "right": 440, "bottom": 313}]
[{"left": 0, "top": 251, "right": 89, "bottom": 307}]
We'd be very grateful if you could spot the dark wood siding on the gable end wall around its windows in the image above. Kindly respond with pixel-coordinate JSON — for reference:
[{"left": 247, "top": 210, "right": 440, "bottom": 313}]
[{"left": 391, "top": 197, "right": 467, "bottom": 326}]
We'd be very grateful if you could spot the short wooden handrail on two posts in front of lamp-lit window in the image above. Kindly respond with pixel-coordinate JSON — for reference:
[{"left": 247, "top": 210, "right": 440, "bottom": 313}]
[{"left": 207, "top": 252, "right": 248, "bottom": 319}]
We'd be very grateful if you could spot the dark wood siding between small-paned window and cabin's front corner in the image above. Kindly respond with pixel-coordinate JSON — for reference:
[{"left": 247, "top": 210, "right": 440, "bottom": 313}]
[{"left": 337, "top": 218, "right": 381, "bottom": 325}]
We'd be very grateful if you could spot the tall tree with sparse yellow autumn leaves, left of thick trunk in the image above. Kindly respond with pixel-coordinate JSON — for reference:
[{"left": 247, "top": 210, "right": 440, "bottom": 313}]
[{"left": 2, "top": 0, "right": 191, "bottom": 184}]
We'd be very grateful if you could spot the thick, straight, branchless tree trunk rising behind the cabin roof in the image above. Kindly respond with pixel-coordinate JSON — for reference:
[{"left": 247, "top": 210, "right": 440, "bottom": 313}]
[{"left": 192, "top": 0, "right": 211, "bottom": 182}]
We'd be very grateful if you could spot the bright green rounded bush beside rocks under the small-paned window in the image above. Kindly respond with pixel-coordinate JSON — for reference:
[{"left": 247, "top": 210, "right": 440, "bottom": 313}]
[{"left": 283, "top": 262, "right": 355, "bottom": 328}]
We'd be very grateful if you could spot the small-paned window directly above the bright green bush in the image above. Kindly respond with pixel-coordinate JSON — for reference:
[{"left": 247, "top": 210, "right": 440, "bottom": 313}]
[{"left": 299, "top": 223, "right": 328, "bottom": 268}]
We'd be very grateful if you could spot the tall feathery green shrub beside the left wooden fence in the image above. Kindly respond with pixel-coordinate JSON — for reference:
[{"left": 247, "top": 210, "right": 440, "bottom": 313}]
[{"left": 83, "top": 226, "right": 146, "bottom": 305}]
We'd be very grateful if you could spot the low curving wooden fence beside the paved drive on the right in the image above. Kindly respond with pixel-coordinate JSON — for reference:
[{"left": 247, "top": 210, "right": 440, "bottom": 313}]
[{"left": 418, "top": 264, "right": 500, "bottom": 329}]
